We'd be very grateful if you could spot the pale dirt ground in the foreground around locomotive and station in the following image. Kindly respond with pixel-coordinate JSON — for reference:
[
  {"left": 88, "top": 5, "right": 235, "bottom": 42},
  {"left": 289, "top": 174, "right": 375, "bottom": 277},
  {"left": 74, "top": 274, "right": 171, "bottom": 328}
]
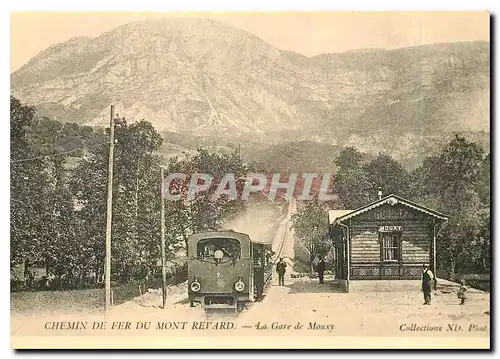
[{"left": 11, "top": 278, "right": 490, "bottom": 340}]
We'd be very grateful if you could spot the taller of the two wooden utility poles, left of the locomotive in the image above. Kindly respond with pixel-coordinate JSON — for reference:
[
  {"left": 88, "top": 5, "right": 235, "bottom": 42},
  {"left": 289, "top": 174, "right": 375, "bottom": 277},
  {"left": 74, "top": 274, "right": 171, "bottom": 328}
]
[{"left": 104, "top": 105, "right": 115, "bottom": 313}]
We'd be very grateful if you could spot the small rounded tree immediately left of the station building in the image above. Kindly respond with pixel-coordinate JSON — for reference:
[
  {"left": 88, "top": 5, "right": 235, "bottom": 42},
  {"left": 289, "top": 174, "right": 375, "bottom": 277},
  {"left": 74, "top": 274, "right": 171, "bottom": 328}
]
[{"left": 292, "top": 202, "right": 331, "bottom": 272}]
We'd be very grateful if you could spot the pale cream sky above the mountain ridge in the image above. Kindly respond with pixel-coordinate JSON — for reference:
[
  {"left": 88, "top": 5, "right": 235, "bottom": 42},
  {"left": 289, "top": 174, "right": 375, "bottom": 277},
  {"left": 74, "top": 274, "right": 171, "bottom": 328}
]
[{"left": 10, "top": 11, "right": 490, "bottom": 72}]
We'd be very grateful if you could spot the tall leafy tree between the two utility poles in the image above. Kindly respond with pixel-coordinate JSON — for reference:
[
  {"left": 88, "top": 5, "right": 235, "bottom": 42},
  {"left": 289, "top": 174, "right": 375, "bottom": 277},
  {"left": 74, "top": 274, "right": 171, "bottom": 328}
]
[{"left": 113, "top": 120, "right": 163, "bottom": 281}]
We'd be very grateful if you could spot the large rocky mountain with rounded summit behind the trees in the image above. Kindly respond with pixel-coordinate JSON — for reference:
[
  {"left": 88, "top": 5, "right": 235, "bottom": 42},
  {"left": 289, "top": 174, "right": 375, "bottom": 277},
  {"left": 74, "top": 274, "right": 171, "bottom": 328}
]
[{"left": 11, "top": 19, "right": 490, "bottom": 164}]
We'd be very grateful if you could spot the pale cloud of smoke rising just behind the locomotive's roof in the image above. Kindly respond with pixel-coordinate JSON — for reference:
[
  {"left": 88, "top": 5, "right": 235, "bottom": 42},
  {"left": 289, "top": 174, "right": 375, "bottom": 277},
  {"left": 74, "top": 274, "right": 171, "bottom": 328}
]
[{"left": 223, "top": 202, "right": 283, "bottom": 244}]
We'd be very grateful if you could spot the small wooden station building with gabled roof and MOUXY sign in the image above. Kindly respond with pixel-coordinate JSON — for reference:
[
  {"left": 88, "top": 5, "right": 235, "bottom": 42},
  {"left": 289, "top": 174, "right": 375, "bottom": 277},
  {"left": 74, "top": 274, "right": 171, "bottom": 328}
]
[{"left": 328, "top": 195, "right": 447, "bottom": 291}]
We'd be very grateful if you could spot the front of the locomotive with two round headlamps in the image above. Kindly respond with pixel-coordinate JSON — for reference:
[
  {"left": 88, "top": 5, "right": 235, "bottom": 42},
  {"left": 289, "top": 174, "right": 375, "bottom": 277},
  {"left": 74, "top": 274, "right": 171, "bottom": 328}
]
[{"left": 188, "top": 231, "right": 254, "bottom": 308}]
